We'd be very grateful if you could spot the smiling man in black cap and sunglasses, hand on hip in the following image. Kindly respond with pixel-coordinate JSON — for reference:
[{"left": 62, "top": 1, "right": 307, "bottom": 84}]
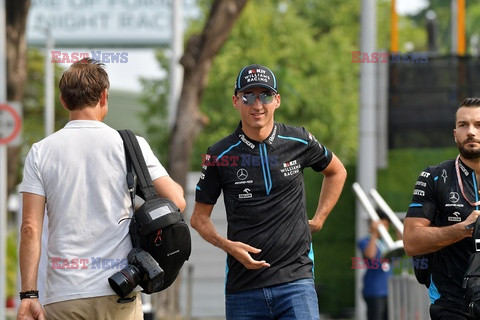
[{"left": 190, "top": 64, "right": 346, "bottom": 320}]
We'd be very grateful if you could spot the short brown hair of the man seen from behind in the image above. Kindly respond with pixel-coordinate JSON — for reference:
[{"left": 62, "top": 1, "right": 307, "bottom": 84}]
[{"left": 58, "top": 58, "right": 110, "bottom": 110}]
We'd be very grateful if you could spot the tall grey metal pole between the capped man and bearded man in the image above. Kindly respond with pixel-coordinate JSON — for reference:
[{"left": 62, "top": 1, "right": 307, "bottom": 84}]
[{"left": 355, "top": 0, "right": 377, "bottom": 320}]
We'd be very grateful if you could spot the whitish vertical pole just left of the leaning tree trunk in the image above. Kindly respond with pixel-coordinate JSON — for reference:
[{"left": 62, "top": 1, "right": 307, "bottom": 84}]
[{"left": 168, "top": 0, "right": 183, "bottom": 129}]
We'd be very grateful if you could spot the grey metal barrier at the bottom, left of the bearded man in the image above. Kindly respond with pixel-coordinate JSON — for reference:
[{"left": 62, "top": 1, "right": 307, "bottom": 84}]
[{"left": 388, "top": 273, "right": 430, "bottom": 320}]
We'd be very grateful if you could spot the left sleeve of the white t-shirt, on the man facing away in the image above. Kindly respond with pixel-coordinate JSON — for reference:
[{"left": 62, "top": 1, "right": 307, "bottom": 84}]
[{"left": 20, "top": 144, "right": 45, "bottom": 197}]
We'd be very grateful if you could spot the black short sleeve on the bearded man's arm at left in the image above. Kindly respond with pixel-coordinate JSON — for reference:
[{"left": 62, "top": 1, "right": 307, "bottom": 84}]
[{"left": 406, "top": 167, "right": 438, "bottom": 222}]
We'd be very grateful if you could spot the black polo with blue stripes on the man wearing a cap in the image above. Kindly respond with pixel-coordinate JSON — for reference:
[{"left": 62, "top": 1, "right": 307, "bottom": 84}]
[{"left": 195, "top": 122, "right": 332, "bottom": 293}]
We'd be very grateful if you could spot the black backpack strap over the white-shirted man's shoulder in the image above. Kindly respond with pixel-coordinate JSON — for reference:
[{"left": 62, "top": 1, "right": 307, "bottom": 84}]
[{"left": 118, "top": 130, "right": 157, "bottom": 201}]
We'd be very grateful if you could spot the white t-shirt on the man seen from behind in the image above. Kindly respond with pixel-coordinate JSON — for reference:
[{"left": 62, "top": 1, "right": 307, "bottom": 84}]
[{"left": 20, "top": 120, "right": 168, "bottom": 304}]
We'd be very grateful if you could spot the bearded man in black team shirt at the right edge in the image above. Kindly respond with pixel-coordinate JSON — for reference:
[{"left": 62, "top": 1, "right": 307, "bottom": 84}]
[{"left": 403, "top": 98, "right": 480, "bottom": 320}]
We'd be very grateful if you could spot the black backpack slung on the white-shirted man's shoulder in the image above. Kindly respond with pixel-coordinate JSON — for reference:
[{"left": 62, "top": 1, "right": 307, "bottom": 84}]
[{"left": 118, "top": 130, "right": 192, "bottom": 293}]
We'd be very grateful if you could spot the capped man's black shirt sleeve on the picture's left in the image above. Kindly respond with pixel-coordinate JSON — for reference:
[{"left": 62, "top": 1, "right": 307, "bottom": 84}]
[{"left": 195, "top": 148, "right": 222, "bottom": 204}]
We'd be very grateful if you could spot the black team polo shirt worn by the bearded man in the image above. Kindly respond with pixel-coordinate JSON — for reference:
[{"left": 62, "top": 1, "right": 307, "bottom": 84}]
[{"left": 406, "top": 160, "right": 480, "bottom": 311}]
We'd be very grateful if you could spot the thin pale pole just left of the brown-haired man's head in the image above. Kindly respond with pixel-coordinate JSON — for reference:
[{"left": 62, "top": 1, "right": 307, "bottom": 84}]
[{"left": 44, "top": 28, "right": 55, "bottom": 137}]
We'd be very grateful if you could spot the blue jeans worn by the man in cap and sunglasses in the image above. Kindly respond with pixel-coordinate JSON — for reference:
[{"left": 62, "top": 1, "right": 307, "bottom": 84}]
[{"left": 225, "top": 279, "right": 320, "bottom": 320}]
